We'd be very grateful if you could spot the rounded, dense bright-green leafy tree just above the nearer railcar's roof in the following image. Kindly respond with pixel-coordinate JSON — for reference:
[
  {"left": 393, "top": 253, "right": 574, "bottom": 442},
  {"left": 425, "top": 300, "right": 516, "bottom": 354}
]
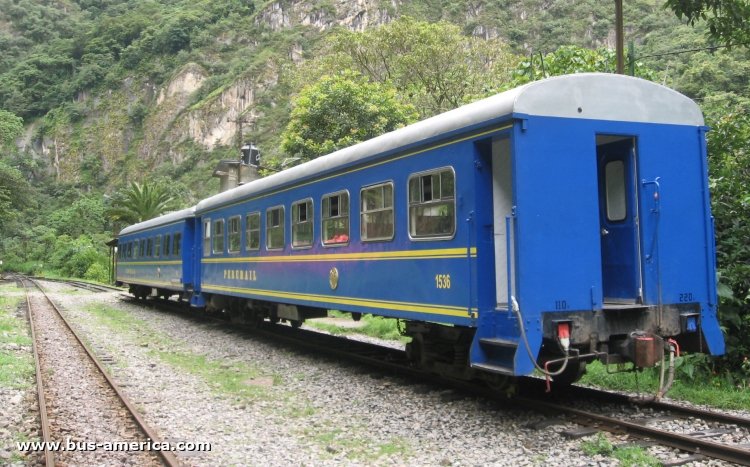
[{"left": 281, "top": 71, "right": 417, "bottom": 160}]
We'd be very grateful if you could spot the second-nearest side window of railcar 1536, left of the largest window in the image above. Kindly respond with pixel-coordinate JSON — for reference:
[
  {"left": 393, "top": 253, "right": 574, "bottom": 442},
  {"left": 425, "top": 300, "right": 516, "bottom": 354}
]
[{"left": 360, "top": 182, "right": 394, "bottom": 242}]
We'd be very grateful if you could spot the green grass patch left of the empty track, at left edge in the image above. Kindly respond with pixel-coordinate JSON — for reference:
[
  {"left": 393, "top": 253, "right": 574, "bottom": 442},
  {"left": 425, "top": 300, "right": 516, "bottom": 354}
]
[{"left": 0, "top": 285, "right": 35, "bottom": 389}]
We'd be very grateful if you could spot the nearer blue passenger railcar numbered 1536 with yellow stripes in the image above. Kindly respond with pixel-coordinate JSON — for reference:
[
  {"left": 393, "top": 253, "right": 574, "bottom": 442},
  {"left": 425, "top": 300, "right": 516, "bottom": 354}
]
[{"left": 126, "top": 74, "right": 724, "bottom": 388}]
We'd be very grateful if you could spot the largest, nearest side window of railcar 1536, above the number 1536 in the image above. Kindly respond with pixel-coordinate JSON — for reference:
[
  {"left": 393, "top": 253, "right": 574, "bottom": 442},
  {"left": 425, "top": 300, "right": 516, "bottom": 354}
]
[{"left": 409, "top": 168, "right": 456, "bottom": 239}]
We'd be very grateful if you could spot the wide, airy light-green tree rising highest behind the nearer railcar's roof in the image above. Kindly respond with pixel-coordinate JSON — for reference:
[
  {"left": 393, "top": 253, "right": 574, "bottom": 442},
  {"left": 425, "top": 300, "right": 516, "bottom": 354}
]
[{"left": 300, "top": 16, "right": 518, "bottom": 118}]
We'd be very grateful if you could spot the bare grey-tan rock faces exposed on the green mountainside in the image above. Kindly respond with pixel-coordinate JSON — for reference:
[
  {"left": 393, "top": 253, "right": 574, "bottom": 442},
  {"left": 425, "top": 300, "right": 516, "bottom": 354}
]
[{"left": 18, "top": 0, "right": 398, "bottom": 181}]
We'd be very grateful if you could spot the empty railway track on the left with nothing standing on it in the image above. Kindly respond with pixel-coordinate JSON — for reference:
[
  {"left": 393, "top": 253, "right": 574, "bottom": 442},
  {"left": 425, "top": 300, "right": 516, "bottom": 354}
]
[{"left": 17, "top": 277, "right": 180, "bottom": 466}]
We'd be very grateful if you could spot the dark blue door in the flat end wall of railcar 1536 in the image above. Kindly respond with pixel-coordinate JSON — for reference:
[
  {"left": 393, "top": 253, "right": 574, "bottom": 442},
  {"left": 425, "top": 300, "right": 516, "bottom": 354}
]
[{"left": 596, "top": 135, "right": 643, "bottom": 303}]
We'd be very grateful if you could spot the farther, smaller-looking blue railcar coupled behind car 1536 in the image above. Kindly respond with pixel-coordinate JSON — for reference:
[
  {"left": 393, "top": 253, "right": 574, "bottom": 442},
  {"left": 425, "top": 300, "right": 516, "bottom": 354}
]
[{"left": 116, "top": 208, "right": 195, "bottom": 298}]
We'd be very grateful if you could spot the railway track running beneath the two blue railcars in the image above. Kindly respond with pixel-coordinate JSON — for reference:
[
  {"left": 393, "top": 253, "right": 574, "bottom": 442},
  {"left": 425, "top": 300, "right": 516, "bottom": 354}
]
[{"left": 122, "top": 295, "right": 750, "bottom": 465}]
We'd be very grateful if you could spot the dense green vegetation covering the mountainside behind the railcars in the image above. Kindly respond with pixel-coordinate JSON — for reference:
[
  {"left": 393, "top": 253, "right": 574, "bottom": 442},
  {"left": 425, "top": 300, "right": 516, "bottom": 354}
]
[{"left": 0, "top": 0, "right": 750, "bottom": 384}]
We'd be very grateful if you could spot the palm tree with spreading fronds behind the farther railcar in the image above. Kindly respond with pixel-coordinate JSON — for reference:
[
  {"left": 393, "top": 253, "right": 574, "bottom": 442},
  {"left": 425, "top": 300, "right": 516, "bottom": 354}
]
[{"left": 108, "top": 182, "right": 177, "bottom": 224}]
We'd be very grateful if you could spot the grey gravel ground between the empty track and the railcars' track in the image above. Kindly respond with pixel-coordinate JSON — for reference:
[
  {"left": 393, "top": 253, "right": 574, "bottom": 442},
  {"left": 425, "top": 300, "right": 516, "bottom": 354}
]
[{"left": 25, "top": 283, "right": 748, "bottom": 466}]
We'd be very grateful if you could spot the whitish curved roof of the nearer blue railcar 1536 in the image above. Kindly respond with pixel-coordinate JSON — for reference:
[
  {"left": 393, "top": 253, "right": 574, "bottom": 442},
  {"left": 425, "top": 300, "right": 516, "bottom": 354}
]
[{"left": 196, "top": 73, "right": 703, "bottom": 214}]
